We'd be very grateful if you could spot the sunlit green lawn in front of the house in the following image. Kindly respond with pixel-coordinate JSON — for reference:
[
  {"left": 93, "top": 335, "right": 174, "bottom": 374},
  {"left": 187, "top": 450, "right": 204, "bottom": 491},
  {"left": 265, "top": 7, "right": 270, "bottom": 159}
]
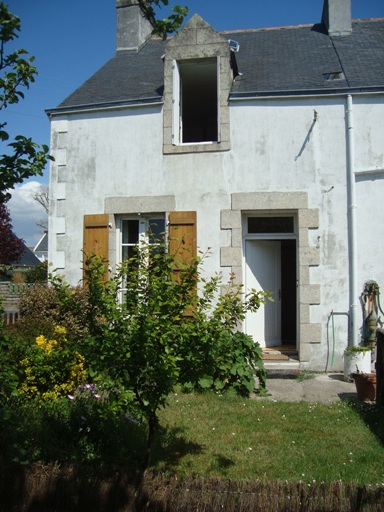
[{"left": 153, "top": 393, "right": 384, "bottom": 485}]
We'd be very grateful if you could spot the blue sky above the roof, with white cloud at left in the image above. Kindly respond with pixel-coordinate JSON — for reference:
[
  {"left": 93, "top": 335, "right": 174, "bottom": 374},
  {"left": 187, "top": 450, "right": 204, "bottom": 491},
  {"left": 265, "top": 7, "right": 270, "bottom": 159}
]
[{"left": 1, "top": 0, "right": 384, "bottom": 245}]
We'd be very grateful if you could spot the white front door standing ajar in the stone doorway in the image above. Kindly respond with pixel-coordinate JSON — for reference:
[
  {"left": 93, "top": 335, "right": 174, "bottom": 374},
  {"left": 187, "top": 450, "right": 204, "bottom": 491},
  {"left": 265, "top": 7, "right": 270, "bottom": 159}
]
[{"left": 245, "top": 240, "right": 281, "bottom": 347}]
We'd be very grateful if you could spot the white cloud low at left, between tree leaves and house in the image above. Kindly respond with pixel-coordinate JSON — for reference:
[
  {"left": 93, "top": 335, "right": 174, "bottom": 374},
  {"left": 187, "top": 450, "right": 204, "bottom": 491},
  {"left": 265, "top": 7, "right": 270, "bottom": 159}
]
[{"left": 7, "top": 181, "right": 47, "bottom": 247}]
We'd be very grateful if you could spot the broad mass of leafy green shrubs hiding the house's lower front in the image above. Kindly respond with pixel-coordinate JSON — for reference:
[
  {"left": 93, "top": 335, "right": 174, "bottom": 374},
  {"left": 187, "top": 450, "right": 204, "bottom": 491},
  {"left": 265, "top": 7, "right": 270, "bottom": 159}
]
[{"left": 0, "top": 242, "right": 268, "bottom": 466}]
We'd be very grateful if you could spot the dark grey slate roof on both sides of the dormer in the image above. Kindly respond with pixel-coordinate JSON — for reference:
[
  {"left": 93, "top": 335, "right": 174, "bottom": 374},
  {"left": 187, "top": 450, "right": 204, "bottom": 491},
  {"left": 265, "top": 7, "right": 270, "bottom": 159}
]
[{"left": 47, "top": 19, "right": 384, "bottom": 113}]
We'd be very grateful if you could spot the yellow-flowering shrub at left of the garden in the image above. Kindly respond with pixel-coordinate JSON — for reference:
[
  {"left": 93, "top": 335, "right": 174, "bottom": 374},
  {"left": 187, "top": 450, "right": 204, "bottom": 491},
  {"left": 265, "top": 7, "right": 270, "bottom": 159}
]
[{"left": 20, "top": 326, "right": 86, "bottom": 400}]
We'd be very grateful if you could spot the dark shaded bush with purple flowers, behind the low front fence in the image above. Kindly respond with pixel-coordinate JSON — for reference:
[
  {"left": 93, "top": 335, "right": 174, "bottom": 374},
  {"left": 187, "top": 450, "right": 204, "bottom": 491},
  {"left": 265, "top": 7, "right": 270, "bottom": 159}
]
[{"left": 0, "top": 386, "right": 142, "bottom": 466}]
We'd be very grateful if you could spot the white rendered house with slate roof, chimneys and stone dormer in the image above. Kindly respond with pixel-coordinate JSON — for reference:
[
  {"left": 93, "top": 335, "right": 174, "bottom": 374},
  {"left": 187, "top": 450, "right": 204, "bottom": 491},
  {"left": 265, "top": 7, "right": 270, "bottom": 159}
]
[{"left": 47, "top": 0, "right": 384, "bottom": 371}]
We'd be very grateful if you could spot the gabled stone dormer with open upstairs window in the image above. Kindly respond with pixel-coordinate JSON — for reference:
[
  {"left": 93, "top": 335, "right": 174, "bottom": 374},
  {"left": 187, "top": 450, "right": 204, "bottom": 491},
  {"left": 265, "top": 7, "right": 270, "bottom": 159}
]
[{"left": 163, "top": 14, "right": 231, "bottom": 154}]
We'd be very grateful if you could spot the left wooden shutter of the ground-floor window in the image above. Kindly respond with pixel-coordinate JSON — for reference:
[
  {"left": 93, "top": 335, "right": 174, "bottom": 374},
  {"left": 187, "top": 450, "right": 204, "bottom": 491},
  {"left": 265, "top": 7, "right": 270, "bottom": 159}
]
[{"left": 83, "top": 214, "right": 109, "bottom": 280}]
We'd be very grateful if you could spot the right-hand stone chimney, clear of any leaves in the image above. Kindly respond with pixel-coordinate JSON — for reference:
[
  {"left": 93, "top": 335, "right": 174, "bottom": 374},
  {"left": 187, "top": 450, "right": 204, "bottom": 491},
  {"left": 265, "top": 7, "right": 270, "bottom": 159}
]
[{"left": 321, "top": 0, "right": 352, "bottom": 37}]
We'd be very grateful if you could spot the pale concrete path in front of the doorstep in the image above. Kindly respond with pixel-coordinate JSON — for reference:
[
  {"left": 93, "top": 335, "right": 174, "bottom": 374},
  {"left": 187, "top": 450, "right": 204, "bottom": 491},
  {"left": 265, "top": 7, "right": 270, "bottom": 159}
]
[{"left": 256, "top": 373, "right": 357, "bottom": 403}]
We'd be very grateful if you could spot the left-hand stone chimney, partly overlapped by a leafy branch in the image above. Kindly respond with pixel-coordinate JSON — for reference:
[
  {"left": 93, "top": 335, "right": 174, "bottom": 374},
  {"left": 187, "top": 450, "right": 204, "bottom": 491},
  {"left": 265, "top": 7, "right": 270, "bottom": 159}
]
[{"left": 116, "top": 0, "right": 153, "bottom": 51}]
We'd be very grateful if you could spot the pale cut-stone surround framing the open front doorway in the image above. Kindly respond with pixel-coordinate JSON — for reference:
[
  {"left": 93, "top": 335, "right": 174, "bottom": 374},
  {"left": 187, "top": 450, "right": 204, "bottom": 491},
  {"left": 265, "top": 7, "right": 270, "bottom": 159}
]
[{"left": 220, "top": 192, "right": 321, "bottom": 362}]
